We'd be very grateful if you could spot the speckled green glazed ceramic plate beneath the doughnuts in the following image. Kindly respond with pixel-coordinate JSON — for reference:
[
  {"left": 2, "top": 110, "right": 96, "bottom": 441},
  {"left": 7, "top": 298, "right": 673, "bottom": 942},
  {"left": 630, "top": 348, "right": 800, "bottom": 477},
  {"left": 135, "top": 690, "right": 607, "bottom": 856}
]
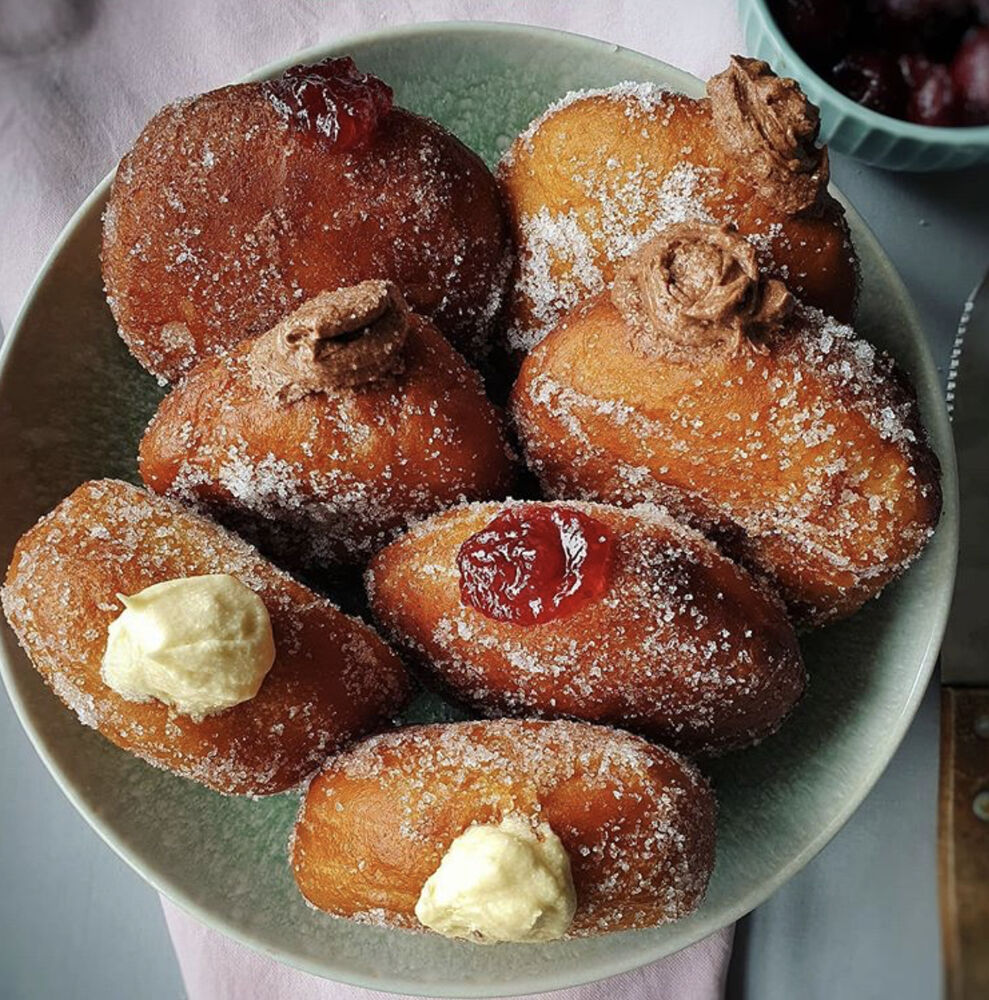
[{"left": 0, "top": 24, "right": 957, "bottom": 997}]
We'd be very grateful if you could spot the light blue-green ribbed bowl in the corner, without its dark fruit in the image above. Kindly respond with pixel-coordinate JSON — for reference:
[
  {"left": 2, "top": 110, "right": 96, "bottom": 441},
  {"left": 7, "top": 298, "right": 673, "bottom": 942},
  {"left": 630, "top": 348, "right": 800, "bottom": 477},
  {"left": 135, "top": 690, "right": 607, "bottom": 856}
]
[{"left": 738, "top": 0, "right": 989, "bottom": 170}]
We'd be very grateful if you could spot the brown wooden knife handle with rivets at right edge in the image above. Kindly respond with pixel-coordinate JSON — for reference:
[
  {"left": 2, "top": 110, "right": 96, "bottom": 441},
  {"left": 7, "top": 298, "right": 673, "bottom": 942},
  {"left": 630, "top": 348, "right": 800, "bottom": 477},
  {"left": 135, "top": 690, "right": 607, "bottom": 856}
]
[{"left": 938, "top": 687, "right": 989, "bottom": 1000}]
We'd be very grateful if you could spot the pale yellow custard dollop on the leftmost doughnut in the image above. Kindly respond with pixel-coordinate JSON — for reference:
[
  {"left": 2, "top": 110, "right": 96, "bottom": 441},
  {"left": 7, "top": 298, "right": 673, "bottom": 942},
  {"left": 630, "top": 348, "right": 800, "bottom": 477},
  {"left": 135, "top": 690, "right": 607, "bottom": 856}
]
[{"left": 102, "top": 573, "right": 275, "bottom": 720}]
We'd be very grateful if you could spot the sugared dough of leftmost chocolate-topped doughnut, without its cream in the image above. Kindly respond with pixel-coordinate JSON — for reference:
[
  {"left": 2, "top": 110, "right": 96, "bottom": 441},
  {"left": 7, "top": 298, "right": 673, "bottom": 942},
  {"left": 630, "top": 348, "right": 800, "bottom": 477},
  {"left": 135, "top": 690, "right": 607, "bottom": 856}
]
[{"left": 141, "top": 317, "right": 515, "bottom": 566}]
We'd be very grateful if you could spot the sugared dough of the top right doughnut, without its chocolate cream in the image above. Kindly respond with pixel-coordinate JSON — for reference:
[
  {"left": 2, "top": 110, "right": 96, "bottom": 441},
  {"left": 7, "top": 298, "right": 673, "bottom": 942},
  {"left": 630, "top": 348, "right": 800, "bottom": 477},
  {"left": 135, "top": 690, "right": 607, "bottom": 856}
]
[{"left": 497, "top": 82, "right": 857, "bottom": 352}]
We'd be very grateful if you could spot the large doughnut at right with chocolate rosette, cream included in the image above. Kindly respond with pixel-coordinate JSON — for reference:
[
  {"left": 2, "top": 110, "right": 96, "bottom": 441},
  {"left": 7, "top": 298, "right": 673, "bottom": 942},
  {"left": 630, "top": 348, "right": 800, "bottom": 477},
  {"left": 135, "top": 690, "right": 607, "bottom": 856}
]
[{"left": 512, "top": 223, "right": 941, "bottom": 623}]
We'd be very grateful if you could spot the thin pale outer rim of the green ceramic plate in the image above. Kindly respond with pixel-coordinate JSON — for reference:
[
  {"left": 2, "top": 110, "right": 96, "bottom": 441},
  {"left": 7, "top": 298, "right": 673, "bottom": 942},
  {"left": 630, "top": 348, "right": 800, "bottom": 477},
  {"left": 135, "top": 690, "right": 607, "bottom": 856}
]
[{"left": 0, "top": 20, "right": 958, "bottom": 998}]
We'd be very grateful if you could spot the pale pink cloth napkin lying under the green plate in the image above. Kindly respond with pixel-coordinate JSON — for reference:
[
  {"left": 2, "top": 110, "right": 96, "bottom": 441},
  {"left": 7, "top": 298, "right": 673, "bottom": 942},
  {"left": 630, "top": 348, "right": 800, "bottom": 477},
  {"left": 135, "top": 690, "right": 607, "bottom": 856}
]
[{"left": 0, "top": 0, "right": 742, "bottom": 1000}]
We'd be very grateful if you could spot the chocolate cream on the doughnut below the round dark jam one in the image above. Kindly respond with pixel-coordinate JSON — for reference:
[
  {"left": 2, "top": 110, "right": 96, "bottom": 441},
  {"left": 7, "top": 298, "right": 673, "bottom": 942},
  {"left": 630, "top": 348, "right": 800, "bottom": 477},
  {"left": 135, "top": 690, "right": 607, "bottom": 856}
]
[{"left": 248, "top": 280, "right": 409, "bottom": 405}]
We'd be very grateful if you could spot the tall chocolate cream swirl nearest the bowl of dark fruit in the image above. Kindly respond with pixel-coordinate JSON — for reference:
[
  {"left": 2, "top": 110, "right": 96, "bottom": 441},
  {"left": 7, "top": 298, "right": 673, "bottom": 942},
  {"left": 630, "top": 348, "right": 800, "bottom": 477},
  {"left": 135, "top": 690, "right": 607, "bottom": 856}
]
[{"left": 707, "top": 56, "right": 830, "bottom": 215}]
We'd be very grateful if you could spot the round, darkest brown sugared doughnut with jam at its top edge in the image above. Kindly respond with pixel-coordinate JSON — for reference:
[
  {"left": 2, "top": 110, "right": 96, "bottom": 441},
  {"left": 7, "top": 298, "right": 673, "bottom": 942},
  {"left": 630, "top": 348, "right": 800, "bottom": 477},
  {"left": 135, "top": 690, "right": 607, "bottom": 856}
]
[{"left": 103, "top": 59, "right": 509, "bottom": 381}]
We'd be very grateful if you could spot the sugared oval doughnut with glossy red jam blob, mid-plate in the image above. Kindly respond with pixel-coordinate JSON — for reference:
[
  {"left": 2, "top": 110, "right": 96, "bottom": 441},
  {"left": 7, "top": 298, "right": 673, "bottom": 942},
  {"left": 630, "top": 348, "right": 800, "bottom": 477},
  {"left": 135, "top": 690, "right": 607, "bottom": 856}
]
[{"left": 367, "top": 501, "right": 805, "bottom": 753}]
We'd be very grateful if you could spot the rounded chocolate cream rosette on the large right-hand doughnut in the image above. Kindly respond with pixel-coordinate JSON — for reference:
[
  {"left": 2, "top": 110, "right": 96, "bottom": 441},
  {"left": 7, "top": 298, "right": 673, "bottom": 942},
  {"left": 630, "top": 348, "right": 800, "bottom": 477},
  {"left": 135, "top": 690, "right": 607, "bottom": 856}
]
[{"left": 611, "top": 222, "right": 793, "bottom": 362}]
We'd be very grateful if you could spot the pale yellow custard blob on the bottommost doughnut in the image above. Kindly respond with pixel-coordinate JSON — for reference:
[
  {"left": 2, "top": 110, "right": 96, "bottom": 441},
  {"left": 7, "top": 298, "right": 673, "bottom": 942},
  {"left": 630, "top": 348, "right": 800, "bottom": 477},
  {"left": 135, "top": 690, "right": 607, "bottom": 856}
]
[{"left": 415, "top": 816, "right": 577, "bottom": 943}]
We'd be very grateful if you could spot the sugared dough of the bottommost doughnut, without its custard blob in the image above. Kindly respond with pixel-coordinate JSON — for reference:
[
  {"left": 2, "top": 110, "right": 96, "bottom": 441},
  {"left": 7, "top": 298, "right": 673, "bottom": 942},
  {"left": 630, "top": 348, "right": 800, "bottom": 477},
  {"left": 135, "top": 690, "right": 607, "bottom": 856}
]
[{"left": 292, "top": 719, "right": 715, "bottom": 940}]
